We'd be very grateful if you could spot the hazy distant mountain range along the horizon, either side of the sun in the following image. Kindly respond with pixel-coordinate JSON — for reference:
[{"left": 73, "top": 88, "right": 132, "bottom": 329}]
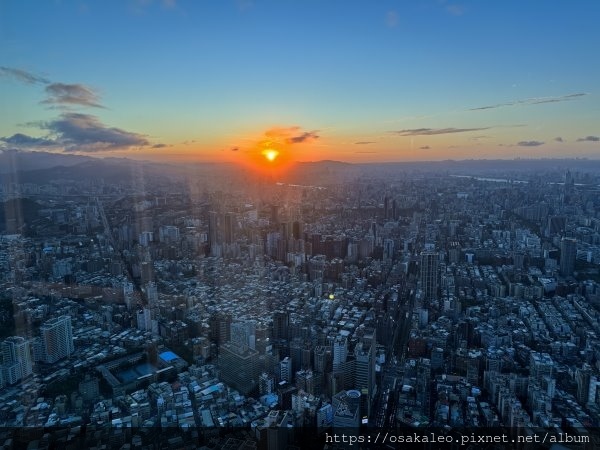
[{"left": 0, "top": 150, "right": 600, "bottom": 184}]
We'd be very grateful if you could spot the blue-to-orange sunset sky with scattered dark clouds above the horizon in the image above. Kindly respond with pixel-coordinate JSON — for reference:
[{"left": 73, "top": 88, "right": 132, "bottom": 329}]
[{"left": 0, "top": 0, "right": 600, "bottom": 162}]
